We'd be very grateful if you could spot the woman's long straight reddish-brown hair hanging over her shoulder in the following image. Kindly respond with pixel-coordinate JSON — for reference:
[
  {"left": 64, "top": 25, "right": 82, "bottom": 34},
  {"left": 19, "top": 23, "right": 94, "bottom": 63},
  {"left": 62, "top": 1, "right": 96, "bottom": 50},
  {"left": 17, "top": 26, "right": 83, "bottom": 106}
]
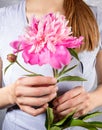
[{"left": 63, "top": 0, "right": 99, "bottom": 51}]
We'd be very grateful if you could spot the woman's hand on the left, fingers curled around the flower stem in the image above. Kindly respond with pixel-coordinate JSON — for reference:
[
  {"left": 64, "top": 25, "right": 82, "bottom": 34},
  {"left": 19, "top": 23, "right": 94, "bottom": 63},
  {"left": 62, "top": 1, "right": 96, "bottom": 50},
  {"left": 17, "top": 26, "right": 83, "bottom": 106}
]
[{"left": 12, "top": 76, "right": 58, "bottom": 116}]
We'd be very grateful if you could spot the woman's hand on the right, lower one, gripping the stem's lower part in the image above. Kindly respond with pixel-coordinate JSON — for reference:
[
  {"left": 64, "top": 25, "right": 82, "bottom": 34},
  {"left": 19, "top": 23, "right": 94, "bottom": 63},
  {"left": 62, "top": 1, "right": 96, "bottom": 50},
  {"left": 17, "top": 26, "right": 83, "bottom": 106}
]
[{"left": 53, "top": 86, "right": 96, "bottom": 118}]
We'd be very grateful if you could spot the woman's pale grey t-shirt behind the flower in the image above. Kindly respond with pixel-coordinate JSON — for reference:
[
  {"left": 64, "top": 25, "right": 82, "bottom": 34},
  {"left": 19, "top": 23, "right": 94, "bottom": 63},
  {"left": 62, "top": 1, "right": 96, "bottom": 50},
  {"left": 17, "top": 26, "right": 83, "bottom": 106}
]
[{"left": 0, "top": 0, "right": 102, "bottom": 130}]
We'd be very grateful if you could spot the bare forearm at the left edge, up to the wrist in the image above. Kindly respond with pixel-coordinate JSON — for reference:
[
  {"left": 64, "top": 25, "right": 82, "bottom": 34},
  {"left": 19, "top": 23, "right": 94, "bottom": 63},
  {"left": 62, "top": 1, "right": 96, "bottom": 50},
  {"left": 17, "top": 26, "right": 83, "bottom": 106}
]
[{"left": 0, "top": 85, "right": 14, "bottom": 109}]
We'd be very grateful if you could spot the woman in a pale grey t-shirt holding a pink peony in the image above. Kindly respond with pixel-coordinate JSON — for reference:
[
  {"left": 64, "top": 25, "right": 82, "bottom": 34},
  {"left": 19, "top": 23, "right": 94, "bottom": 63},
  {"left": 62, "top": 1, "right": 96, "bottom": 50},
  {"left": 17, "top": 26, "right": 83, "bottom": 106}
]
[{"left": 0, "top": 0, "right": 102, "bottom": 130}]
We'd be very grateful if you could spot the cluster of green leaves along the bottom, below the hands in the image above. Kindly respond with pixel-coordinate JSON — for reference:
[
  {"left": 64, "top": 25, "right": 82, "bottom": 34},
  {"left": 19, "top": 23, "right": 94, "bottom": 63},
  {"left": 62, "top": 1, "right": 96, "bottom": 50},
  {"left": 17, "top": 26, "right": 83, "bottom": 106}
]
[{"left": 45, "top": 107, "right": 102, "bottom": 130}]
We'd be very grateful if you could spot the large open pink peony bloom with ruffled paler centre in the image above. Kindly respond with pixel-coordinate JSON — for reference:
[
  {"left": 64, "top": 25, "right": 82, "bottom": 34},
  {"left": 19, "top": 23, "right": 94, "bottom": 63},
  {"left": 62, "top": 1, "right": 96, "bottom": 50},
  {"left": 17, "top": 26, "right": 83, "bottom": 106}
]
[{"left": 11, "top": 13, "right": 83, "bottom": 69}]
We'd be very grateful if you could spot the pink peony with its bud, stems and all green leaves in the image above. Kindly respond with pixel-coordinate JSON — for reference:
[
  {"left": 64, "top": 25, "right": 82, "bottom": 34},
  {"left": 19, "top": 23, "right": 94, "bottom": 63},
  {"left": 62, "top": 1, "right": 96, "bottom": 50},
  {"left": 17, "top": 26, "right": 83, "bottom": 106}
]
[{"left": 5, "top": 13, "right": 102, "bottom": 130}]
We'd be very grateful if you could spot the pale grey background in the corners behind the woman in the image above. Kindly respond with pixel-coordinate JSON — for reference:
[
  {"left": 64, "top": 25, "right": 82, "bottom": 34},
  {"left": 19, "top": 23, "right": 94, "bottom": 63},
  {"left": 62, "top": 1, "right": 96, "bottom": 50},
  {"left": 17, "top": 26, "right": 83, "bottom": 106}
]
[{"left": 0, "top": 0, "right": 102, "bottom": 130}]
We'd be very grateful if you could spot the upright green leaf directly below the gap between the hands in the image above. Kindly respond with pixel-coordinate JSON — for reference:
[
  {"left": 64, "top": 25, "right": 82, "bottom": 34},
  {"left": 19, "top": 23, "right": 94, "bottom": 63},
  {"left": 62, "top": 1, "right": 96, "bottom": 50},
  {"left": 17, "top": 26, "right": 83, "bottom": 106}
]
[{"left": 45, "top": 107, "right": 54, "bottom": 130}]
